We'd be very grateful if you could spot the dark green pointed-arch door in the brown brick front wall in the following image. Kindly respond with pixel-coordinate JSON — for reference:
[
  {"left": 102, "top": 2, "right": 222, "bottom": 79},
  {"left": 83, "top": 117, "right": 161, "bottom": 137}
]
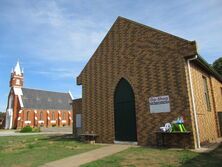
[{"left": 114, "top": 78, "right": 137, "bottom": 142}]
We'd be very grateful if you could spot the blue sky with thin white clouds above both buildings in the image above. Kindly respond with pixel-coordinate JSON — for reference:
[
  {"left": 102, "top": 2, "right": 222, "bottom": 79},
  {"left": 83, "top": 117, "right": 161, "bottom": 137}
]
[{"left": 0, "top": 0, "right": 222, "bottom": 111}]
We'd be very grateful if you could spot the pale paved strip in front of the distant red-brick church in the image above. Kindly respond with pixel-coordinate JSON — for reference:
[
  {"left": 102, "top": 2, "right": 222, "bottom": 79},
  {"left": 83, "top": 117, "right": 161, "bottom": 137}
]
[{"left": 0, "top": 130, "right": 72, "bottom": 137}]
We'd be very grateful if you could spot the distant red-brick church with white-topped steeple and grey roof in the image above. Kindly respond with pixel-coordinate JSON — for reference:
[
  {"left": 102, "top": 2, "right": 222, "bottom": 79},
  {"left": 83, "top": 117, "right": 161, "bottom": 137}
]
[{"left": 5, "top": 62, "right": 72, "bottom": 129}]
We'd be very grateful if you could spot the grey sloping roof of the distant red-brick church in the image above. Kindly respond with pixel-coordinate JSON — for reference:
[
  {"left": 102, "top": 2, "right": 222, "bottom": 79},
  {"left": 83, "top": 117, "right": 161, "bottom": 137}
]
[{"left": 21, "top": 88, "right": 72, "bottom": 110}]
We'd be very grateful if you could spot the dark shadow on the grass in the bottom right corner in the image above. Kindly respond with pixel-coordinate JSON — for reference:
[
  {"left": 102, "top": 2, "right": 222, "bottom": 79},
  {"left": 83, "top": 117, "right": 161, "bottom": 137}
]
[{"left": 181, "top": 144, "right": 222, "bottom": 167}]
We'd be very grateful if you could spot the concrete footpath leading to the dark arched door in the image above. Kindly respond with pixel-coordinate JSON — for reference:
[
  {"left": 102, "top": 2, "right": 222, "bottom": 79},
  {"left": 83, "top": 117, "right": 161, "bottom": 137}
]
[{"left": 41, "top": 144, "right": 130, "bottom": 167}]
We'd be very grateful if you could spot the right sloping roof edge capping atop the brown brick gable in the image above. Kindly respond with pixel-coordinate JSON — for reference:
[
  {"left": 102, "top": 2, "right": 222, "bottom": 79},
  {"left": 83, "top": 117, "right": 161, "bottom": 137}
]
[{"left": 116, "top": 16, "right": 195, "bottom": 43}]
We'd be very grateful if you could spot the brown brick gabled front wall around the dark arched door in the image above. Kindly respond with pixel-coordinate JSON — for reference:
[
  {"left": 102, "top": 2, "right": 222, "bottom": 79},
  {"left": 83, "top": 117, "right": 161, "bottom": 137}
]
[{"left": 77, "top": 19, "right": 196, "bottom": 146}]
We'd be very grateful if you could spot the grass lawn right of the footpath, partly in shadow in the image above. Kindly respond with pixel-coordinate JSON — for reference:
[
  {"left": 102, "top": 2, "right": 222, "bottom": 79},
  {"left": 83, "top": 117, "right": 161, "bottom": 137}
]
[{"left": 81, "top": 145, "right": 222, "bottom": 167}]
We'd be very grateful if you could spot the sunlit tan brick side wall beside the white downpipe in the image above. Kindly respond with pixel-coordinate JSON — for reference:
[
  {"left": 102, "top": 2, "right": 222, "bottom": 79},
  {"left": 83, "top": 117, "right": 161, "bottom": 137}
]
[{"left": 191, "top": 63, "right": 218, "bottom": 144}]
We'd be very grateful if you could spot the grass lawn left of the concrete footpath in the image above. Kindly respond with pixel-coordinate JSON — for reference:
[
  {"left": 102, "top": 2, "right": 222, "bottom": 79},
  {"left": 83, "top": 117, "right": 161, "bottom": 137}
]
[{"left": 0, "top": 135, "right": 101, "bottom": 167}]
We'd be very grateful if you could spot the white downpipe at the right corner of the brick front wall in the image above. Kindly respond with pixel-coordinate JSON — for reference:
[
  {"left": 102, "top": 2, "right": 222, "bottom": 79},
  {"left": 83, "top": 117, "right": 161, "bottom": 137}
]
[{"left": 187, "top": 55, "right": 200, "bottom": 148}]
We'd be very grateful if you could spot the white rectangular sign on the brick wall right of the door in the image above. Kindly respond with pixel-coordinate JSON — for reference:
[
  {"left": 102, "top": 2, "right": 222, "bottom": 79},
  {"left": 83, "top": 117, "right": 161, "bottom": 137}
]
[{"left": 149, "top": 95, "right": 170, "bottom": 113}]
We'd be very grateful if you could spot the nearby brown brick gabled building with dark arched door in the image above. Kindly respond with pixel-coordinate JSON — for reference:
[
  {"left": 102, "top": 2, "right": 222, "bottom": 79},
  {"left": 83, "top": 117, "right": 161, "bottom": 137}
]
[{"left": 73, "top": 17, "right": 222, "bottom": 148}]
